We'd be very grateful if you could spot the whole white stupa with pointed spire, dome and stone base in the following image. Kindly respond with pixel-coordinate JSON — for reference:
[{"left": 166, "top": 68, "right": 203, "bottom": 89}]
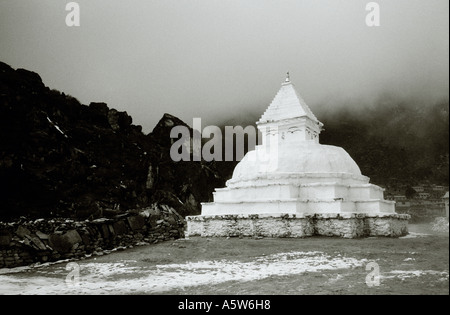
[{"left": 187, "top": 75, "right": 409, "bottom": 237}]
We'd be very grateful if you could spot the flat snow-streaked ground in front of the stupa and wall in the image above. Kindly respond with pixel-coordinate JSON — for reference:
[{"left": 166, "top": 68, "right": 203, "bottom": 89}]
[{"left": 0, "top": 225, "right": 449, "bottom": 294}]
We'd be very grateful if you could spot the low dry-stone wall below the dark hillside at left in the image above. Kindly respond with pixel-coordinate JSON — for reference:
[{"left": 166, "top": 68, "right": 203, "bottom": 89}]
[{"left": 0, "top": 205, "right": 185, "bottom": 268}]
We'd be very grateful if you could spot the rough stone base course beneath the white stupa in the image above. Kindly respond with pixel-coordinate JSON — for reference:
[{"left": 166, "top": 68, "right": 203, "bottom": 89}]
[{"left": 186, "top": 213, "right": 410, "bottom": 238}]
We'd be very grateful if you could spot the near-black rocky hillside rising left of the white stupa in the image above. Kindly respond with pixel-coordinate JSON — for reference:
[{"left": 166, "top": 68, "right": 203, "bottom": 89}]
[{"left": 0, "top": 62, "right": 224, "bottom": 219}]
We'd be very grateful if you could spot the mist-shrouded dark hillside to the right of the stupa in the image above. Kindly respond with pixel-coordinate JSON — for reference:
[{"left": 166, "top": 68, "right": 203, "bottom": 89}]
[{"left": 320, "top": 98, "right": 449, "bottom": 185}]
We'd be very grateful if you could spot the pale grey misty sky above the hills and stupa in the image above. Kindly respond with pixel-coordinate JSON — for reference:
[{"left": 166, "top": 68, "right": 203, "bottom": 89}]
[{"left": 0, "top": 0, "right": 449, "bottom": 132}]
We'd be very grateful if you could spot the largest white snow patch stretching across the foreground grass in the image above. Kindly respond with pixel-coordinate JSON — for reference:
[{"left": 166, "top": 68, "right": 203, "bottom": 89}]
[{"left": 0, "top": 251, "right": 366, "bottom": 294}]
